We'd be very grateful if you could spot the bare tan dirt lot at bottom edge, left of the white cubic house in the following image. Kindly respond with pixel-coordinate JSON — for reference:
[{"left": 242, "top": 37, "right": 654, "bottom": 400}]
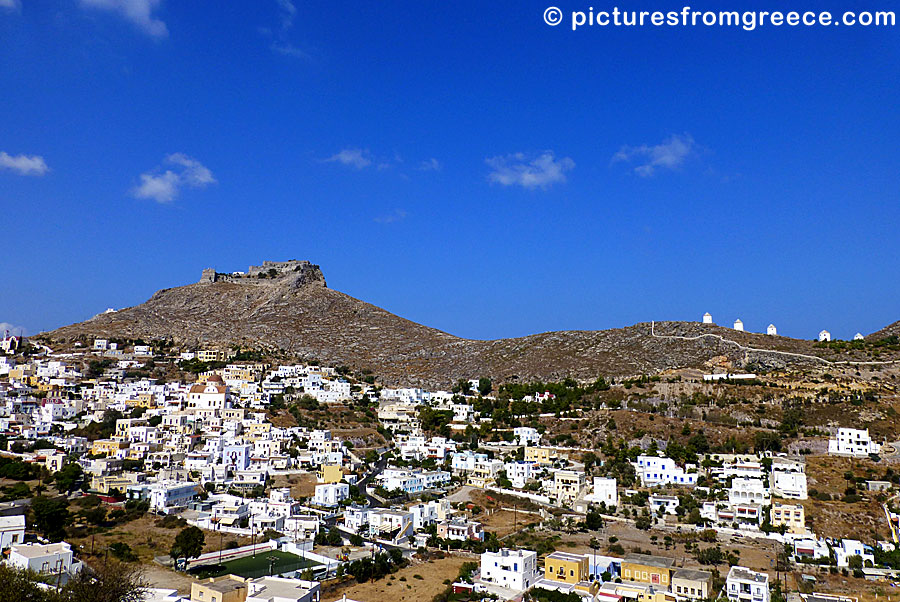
[{"left": 322, "top": 556, "right": 471, "bottom": 602}]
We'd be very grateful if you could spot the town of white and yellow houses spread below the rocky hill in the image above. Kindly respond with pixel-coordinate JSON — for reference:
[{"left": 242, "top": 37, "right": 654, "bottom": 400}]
[{"left": 0, "top": 328, "right": 900, "bottom": 602}]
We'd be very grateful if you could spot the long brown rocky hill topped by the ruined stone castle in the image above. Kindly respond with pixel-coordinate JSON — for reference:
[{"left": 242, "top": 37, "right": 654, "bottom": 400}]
[{"left": 46, "top": 261, "right": 900, "bottom": 386}]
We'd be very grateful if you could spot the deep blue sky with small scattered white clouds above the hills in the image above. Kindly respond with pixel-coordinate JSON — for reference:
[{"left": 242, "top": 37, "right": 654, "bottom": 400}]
[{"left": 0, "top": 0, "right": 900, "bottom": 338}]
